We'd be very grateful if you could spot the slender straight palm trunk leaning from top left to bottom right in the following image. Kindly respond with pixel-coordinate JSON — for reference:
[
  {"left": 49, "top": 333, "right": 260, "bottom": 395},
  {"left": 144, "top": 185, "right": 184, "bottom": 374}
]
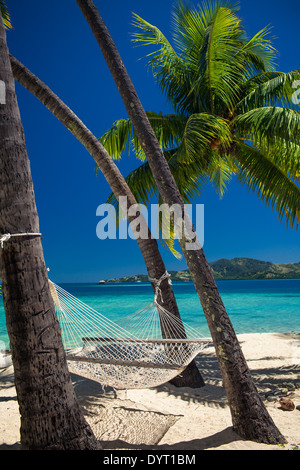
[{"left": 76, "top": 0, "right": 285, "bottom": 444}]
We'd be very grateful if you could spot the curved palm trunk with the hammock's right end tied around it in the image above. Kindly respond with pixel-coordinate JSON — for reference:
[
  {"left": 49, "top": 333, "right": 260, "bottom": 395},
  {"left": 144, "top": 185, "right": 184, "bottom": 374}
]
[{"left": 10, "top": 55, "right": 204, "bottom": 388}]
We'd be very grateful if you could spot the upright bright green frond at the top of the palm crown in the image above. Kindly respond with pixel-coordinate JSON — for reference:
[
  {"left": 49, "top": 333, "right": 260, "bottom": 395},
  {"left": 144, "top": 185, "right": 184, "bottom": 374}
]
[{"left": 164, "top": 1, "right": 245, "bottom": 114}]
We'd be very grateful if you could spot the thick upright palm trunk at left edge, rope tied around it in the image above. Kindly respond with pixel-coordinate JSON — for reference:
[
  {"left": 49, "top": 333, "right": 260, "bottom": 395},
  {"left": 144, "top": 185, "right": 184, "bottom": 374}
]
[{"left": 0, "top": 14, "right": 97, "bottom": 450}]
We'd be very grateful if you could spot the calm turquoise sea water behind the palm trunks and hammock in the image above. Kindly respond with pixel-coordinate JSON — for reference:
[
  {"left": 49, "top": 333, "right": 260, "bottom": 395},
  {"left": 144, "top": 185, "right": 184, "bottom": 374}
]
[{"left": 0, "top": 279, "right": 300, "bottom": 344}]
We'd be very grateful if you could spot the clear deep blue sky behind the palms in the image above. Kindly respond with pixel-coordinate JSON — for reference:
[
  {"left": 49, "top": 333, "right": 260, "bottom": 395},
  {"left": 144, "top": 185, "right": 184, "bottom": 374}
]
[{"left": 7, "top": 0, "right": 300, "bottom": 282}]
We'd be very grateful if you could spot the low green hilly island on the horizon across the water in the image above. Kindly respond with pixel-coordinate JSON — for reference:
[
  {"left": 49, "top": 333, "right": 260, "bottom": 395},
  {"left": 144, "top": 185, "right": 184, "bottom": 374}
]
[{"left": 99, "top": 258, "right": 300, "bottom": 284}]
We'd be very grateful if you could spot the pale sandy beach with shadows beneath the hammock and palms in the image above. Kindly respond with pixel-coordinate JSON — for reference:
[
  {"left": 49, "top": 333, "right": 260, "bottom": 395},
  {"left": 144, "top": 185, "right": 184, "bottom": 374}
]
[{"left": 0, "top": 333, "right": 300, "bottom": 451}]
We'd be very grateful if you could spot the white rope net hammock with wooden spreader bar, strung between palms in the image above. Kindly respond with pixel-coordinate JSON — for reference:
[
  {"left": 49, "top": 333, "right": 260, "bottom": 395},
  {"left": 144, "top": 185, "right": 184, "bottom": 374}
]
[{"left": 49, "top": 281, "right": 211, "bottom": 389}]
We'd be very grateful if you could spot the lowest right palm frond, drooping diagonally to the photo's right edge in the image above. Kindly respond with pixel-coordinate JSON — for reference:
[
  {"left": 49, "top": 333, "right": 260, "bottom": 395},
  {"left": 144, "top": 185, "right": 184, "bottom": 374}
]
[{"left": 233, "top": 143, "right": 300, "bottom": 227}]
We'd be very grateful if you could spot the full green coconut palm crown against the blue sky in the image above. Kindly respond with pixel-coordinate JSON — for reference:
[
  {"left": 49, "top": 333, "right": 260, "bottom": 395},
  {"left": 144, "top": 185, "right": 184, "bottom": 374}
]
[{"left": 100, "top": 1, "right": 300, "bottom": 242}]
